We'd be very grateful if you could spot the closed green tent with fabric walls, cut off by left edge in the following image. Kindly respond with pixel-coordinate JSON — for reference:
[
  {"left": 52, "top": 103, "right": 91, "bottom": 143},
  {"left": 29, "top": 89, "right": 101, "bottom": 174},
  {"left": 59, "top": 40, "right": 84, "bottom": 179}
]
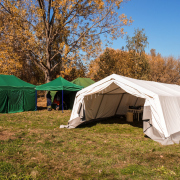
[{"left": 0, "top": 74, "right": 37, "bottom": 113}]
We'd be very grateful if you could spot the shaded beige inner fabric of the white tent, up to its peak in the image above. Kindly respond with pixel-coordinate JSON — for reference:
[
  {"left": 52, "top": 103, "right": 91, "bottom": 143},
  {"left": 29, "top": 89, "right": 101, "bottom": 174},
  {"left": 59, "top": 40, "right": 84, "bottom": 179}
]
[{"left": 84, "top": 83, "right": 145, "bottom": 121}]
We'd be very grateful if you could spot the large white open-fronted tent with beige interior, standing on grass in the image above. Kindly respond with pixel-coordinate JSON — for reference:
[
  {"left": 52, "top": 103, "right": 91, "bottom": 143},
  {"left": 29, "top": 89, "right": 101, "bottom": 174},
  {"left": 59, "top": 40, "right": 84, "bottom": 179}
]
[{"left": 60, "top": 74, "right": 180, "bottom": 145}]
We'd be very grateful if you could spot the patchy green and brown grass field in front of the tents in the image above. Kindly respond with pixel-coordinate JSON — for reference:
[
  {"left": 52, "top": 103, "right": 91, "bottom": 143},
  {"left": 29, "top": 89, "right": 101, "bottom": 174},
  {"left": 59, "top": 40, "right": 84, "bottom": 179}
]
[{"left": 0, "top": 110, "right": 180, "bottom": 180}]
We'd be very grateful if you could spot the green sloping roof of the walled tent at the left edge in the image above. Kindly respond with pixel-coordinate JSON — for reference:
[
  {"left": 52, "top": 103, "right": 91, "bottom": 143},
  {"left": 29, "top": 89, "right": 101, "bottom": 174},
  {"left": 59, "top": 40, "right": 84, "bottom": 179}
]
[{"left": 0, "top": 74, "right": 35, "bottom": 89}]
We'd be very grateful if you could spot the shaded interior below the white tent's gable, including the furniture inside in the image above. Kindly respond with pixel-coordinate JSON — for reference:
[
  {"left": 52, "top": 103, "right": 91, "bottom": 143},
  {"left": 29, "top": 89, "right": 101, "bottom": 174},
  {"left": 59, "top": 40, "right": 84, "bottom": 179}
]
[{"left": 84, "top": 92, "right": 145, "bottom": 122}]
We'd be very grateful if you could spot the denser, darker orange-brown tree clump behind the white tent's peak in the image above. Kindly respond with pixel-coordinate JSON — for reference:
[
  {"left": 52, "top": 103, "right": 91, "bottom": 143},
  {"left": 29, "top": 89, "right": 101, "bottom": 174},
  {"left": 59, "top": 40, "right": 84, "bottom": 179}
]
[{"left": 88, "top": 48, "right": 149, "bottom": 81}]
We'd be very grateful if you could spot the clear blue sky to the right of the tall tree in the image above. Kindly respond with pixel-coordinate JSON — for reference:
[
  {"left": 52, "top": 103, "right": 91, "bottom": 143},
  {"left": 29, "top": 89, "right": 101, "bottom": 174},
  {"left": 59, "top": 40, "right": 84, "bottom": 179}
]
[{"left": 105, "top": 0, "right": 180, "bottom": 58}]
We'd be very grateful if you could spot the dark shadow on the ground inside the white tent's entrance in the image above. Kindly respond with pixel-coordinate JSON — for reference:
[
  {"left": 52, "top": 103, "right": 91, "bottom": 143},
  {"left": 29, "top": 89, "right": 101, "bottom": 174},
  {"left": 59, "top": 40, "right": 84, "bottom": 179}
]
[{"left": 76, "top": 116, "right": 143, "bottom": 128}]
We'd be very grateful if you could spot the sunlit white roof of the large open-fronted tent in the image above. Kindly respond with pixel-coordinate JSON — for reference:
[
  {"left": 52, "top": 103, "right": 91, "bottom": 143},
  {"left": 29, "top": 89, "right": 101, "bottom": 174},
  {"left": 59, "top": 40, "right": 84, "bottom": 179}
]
[{"left": 77, "top": 74, "right": 180, "bottom": 97}]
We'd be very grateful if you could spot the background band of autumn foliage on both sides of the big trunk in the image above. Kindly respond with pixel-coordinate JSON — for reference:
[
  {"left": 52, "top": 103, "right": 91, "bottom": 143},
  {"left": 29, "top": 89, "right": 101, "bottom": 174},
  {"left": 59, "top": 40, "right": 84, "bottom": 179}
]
[{"left": 0, "top": 22, "right": 180, "bottom": 85}]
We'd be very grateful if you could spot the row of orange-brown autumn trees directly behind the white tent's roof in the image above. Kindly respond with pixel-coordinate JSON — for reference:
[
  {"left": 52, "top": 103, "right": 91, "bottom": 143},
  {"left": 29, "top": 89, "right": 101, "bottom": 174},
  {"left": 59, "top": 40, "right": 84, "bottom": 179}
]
[{"left": 88, "top": 48, "right": 180, "bottom": 84}]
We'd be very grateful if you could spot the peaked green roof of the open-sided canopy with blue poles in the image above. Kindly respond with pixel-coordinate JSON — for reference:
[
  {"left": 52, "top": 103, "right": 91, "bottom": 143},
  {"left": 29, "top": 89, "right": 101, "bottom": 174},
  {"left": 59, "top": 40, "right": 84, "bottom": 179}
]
[{"left": 36, "top": 77, "right": 83, "bottom": 91}]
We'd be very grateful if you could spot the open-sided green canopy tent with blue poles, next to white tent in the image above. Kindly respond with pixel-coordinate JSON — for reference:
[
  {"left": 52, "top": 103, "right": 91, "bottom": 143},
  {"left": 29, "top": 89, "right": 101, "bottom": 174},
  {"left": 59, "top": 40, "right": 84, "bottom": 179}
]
[{"left": 36, "top": 77, "right": 83, "bottom": 109}]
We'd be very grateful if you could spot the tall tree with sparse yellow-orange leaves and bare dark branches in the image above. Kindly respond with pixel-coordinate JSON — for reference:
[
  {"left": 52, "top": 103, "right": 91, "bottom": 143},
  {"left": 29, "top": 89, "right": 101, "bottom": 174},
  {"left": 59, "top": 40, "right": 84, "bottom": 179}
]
[{"left": 0, "top": 0, "right": 132, "bottom": 82}]
